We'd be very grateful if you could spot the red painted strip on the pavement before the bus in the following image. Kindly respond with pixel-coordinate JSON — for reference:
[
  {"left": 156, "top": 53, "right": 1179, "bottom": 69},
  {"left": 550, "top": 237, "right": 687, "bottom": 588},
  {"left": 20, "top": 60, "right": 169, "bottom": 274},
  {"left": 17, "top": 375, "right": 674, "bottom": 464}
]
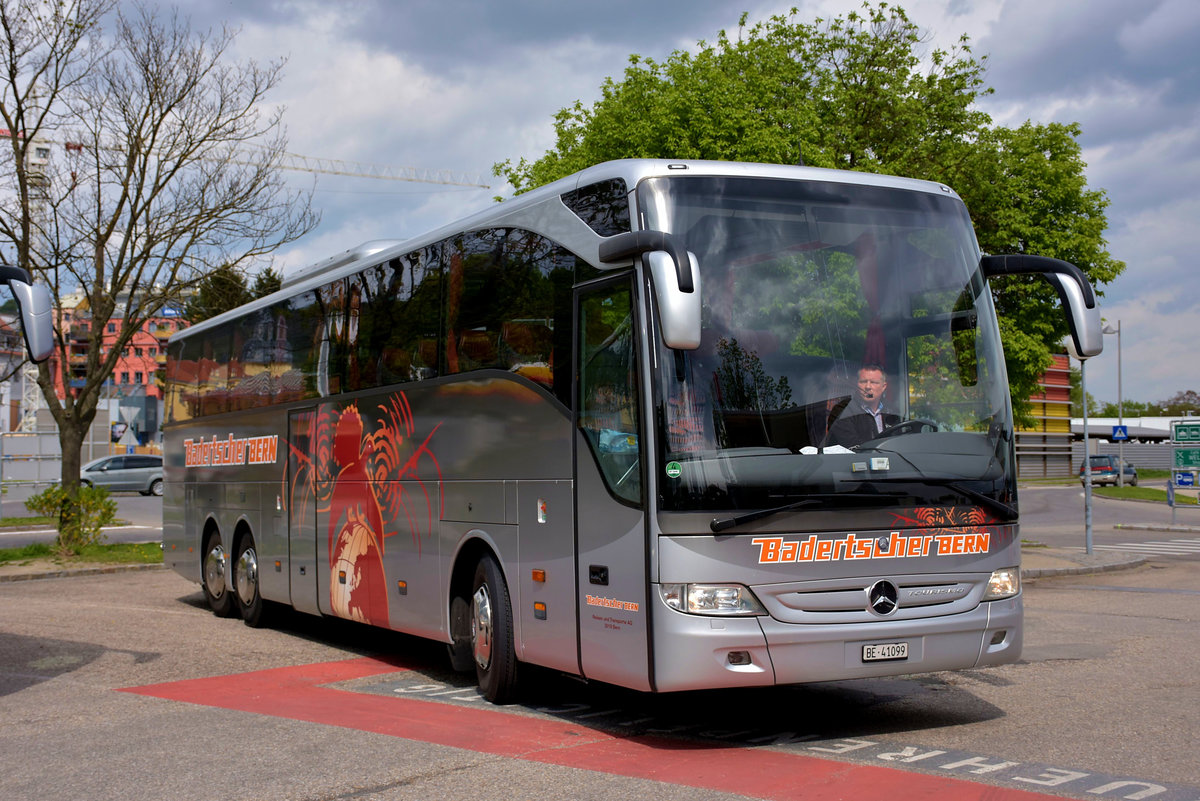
[{"left": 121, "top": 657, "right": 1056, "bottom": 801}]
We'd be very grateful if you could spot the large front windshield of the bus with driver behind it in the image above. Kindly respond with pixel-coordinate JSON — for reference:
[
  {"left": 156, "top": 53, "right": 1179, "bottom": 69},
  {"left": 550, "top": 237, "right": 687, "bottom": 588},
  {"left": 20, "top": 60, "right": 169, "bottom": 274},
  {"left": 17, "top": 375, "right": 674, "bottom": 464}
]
[{"left": 637, "top": 176, "right": 1015, "bottom": 520}]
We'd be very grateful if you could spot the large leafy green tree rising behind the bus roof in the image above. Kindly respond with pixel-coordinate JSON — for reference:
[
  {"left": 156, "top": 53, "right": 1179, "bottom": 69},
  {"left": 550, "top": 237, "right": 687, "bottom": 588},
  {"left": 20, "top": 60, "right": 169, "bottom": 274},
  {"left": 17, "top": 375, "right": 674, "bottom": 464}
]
[{"left": 494, "top": 2, "right": 1124, "bottom": 422}]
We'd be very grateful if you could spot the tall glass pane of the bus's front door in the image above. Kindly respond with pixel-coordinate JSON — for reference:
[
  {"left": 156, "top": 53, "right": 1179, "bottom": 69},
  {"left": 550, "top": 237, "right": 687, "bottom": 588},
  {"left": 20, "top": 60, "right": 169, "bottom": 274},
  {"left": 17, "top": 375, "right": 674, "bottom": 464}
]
[{"left": 578, "top": 282, "right": 642, "bottom": 505}]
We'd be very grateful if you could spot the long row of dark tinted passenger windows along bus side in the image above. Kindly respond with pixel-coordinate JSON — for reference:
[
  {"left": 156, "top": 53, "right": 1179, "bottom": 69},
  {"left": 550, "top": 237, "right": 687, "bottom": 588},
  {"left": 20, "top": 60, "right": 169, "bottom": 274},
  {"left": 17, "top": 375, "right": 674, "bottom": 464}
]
[{"left": 167, "top": 227, "right": 597, "bottom": 422}]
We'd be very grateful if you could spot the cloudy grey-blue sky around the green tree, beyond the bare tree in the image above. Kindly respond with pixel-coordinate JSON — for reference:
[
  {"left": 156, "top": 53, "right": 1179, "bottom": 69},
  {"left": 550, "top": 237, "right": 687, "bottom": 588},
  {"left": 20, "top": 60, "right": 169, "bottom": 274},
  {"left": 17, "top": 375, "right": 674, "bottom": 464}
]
[{"left": 171, "top": 0, "right": 1200, "bottom": 410}]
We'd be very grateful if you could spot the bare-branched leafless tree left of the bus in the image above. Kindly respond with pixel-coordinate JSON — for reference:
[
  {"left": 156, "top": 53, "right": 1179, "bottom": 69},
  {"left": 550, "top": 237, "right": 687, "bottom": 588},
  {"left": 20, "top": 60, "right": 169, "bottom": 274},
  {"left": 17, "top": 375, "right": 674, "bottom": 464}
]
[{"left": 0, "top": 0, "right": 317, "bottom": 551}]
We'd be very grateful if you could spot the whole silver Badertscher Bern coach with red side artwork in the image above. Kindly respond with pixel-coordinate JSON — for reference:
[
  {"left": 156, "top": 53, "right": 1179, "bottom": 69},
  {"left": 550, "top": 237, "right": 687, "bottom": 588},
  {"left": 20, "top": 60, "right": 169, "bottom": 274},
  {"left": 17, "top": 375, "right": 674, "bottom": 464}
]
[{"left": 163, "top": 161, "right": 1100, "bottom": 701}]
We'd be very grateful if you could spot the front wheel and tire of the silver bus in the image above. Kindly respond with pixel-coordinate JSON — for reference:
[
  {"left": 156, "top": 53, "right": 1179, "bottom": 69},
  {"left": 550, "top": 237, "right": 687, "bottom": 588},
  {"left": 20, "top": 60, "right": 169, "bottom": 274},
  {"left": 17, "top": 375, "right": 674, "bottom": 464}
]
[{"left": 470, "top": 556, "right": 517, "bottom": 704}]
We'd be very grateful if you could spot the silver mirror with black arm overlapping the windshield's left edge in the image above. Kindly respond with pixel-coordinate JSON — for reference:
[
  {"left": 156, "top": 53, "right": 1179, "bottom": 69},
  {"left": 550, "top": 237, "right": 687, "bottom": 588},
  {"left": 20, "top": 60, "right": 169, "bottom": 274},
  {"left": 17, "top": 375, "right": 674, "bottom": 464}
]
[{"left": 600, "top": 230, "right": 702, "bottom": 350}]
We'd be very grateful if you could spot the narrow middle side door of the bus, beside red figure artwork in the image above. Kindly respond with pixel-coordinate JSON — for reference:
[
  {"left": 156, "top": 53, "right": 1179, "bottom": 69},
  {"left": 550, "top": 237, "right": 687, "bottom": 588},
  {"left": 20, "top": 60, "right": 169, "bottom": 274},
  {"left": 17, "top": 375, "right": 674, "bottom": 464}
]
[{"left": 284, "top": 409, "right": 320, "bottom": 615}]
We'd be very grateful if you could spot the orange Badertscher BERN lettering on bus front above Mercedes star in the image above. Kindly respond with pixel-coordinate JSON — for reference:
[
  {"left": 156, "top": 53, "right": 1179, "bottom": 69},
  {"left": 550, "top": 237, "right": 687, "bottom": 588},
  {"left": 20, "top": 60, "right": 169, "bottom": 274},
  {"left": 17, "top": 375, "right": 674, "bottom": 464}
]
[{"left": 750, "top": 531, "right": 991, "bottom": 565}]
